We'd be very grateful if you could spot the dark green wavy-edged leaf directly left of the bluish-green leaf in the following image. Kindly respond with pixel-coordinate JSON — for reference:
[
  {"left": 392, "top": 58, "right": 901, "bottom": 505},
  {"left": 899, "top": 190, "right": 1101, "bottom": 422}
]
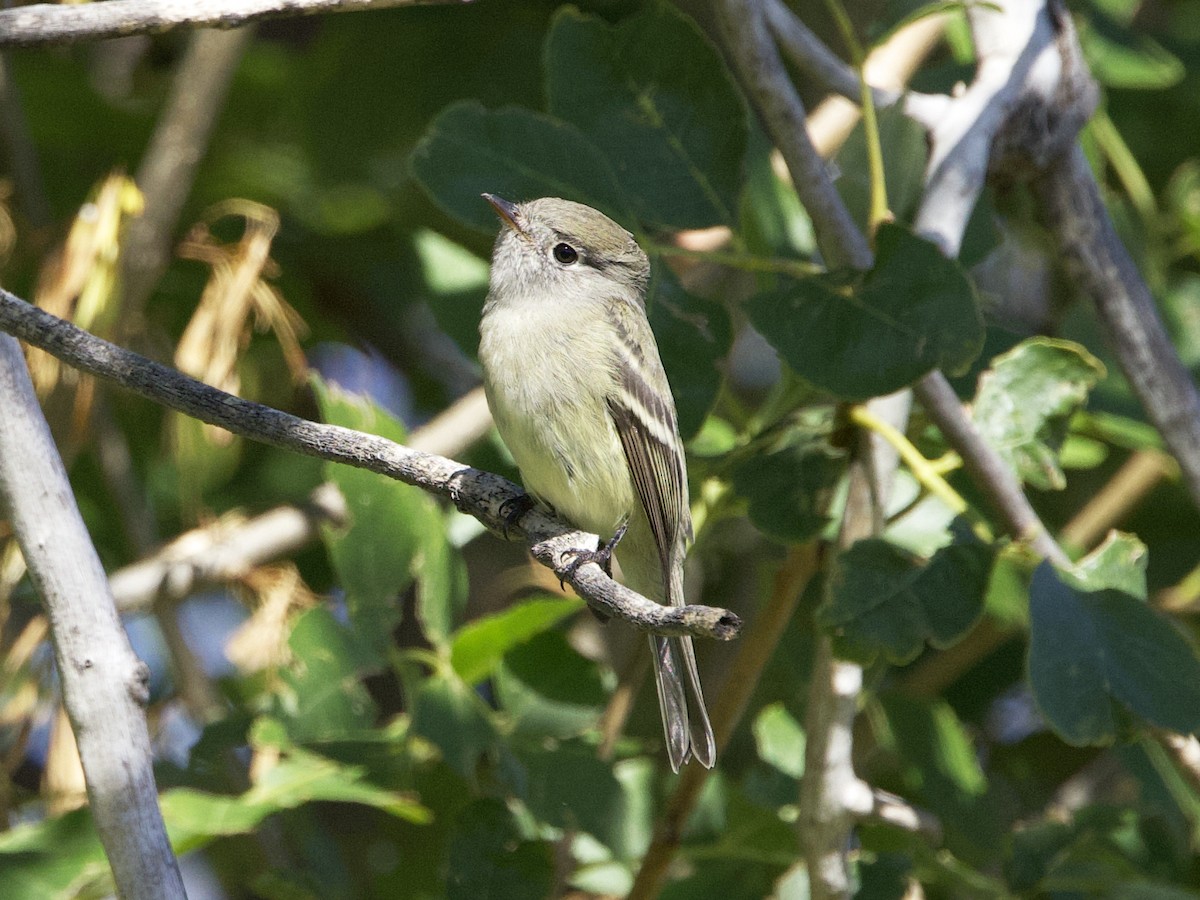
[{"left": 817, "top": 539, "right": 994, "bottom": 664}]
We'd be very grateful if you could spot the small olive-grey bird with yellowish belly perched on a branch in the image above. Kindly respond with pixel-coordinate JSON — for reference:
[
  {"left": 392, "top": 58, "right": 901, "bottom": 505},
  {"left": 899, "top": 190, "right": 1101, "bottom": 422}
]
[{"left": 479, "top": 193, "right": 716, "bottom": 772}]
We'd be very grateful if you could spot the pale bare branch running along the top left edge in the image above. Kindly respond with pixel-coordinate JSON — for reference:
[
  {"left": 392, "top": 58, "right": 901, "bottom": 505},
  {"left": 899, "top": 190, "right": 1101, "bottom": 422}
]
[{"left": 0, "top": 0, "right": 470, "bottom": 47}]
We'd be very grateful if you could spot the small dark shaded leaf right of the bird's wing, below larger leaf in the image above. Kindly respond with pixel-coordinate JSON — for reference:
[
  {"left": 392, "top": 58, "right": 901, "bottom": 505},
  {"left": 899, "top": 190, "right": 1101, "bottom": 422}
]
[{"left": 733, "top": 442, "right": 846, "bottom": 542}]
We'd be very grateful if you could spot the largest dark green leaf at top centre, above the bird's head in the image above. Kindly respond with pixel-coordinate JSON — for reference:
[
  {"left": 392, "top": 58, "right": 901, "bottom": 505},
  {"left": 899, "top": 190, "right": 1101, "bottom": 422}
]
[{"left": 545, "top": 0, "right": 746, "bottom": 228}]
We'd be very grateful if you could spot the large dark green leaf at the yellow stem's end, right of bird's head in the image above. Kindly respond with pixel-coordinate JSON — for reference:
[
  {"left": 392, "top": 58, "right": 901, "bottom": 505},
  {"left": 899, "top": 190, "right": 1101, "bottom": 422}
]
[{"left": 746, "top": 224, "right": 983, "bottom": 400}]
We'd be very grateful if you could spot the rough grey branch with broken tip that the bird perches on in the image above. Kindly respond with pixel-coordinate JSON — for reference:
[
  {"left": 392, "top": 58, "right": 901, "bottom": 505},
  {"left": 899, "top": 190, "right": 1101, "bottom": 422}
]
[{"left": 0, "top": 289, "right": 742, "bottom": 641}]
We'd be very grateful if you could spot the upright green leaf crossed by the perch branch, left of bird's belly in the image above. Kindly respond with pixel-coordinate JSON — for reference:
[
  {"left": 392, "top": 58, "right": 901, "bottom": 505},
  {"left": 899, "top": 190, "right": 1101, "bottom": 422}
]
[{"left": 312, "top": 377, "right": 440, "bottom": 659}]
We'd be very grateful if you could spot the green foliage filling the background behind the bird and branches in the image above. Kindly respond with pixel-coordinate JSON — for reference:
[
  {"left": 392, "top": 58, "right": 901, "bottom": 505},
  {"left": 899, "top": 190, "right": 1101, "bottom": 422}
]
[{"left": 0, "top": 0, "right": 1200, "bottom": 900}]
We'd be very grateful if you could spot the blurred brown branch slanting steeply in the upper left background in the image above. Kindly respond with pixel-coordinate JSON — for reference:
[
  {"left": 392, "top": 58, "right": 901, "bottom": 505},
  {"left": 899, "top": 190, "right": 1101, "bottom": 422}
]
[{"left": 121, "top": 27, "right": 253, "bottom": 328}]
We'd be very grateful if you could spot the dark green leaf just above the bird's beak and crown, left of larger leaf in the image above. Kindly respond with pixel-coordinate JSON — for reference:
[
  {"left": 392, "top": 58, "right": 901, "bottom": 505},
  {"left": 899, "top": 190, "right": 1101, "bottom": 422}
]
[{"left": 409, "top": 101, "right": 635, "bottom": 232}]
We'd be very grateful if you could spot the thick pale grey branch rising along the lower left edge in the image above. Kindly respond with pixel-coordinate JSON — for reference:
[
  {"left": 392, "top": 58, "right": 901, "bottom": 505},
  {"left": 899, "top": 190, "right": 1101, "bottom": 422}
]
[{"left": 0, "top": 335, "right": 185, "bottom": 900}]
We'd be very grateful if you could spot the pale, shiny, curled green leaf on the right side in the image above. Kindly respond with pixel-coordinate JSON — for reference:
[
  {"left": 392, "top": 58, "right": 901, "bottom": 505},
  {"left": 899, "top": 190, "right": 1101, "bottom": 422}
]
[{"left": 972, "top": 337, "right": 1104, "bottom": 490}]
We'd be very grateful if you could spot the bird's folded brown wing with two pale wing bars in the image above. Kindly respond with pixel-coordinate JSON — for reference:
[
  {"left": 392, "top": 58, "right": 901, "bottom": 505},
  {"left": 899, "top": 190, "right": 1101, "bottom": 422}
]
[{"left": 608, "top": 302, "right": 691, "bottom": 580}]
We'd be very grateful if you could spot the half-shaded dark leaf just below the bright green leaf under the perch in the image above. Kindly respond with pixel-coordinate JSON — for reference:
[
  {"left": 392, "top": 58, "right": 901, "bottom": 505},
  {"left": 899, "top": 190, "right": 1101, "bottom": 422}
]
[{"left": 496, "top": 631, "right": 608, "bottom": 738}]
